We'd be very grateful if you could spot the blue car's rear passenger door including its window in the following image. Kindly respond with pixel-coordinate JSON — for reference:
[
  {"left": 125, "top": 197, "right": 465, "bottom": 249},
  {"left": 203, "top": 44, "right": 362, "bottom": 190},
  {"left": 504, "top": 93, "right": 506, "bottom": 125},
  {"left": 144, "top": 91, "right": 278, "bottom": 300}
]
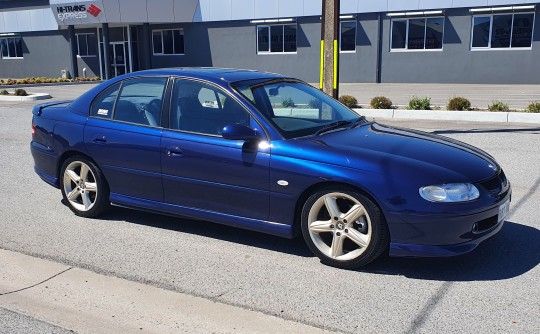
[{"left": 84, "top": 77, "right": 168, "bottom": 201}]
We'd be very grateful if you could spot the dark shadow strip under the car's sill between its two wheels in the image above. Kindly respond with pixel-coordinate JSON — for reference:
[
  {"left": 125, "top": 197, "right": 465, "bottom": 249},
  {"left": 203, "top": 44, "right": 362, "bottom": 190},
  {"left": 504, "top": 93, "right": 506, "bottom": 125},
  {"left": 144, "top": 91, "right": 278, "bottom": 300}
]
[{"left": 100, "top": 207, "right": 314, "bottom": 257}]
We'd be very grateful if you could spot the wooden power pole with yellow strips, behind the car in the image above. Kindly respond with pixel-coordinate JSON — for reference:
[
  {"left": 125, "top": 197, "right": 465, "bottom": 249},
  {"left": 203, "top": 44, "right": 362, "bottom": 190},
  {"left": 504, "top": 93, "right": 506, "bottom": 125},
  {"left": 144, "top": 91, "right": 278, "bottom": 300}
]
[{"left": 319, "top": 0, "right": 339, "bottom": 99}]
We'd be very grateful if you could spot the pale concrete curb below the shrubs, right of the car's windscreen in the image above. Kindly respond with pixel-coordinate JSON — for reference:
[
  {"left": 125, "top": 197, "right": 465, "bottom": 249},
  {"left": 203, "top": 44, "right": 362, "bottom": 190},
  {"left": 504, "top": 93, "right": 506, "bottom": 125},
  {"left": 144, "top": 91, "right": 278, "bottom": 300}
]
[{"left": 353, "top": 109, "right": 540, "bottom": 124}]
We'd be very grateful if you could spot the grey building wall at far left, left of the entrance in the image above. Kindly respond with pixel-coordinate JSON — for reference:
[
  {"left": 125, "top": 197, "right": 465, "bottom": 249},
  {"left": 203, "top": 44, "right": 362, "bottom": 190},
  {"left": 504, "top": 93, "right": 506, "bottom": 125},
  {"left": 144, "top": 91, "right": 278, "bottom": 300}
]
[{"left": 0, "top": 31, "right": 71, "bottom": 78}]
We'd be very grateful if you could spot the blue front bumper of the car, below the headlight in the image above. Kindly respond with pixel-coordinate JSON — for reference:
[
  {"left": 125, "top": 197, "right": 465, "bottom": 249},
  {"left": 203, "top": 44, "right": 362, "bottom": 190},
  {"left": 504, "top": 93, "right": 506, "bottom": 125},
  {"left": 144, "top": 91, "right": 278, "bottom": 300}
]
[{"left": 387, "top": 191, "right": 511, "bottom": 257}]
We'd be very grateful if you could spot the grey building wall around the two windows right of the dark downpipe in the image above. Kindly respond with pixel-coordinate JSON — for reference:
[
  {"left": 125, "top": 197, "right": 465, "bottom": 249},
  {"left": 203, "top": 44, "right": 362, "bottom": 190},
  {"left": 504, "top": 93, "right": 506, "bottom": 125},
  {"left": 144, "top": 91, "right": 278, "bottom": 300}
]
[{"left": 382, "top": 9, "right": 540, "bottom": 84}]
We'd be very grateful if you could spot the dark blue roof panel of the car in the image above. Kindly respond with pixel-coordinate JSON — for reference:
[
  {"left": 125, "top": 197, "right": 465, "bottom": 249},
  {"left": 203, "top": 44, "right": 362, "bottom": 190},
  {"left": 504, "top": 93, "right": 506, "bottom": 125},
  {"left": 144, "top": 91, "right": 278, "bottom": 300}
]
[{"left": 131, "top": 67, "right": 285, "bottom": 83}]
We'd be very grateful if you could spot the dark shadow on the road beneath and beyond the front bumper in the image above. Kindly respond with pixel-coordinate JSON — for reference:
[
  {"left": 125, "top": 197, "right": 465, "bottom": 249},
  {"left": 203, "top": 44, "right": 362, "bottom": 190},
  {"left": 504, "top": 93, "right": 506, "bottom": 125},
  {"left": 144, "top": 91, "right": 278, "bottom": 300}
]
[{"left": 361, "top": 221, "right": 540, "bottom": 281}]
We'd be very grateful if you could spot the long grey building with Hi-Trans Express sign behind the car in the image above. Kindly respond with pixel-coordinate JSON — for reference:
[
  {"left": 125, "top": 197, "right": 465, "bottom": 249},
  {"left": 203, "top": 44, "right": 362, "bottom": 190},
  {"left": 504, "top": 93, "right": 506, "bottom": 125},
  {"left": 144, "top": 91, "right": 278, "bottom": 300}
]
[{"left": 0, "top": 0, "right": 540, "bottom": 84}]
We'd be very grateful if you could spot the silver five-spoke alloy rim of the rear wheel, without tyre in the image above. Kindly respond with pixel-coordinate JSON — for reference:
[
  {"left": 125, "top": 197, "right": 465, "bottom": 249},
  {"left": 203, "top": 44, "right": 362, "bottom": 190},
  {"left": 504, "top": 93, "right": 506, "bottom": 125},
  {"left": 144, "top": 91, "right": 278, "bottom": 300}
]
[{"left": 64, "top": 161, "right": 98, "bottom": 212}]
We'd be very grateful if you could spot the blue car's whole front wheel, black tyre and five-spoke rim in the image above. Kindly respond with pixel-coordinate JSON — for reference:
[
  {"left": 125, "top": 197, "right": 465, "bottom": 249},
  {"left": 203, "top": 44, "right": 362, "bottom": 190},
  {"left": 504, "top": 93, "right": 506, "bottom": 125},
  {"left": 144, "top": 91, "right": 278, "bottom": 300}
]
[{"left": 301, "top": 187, "right": 389, "bottom": 269}]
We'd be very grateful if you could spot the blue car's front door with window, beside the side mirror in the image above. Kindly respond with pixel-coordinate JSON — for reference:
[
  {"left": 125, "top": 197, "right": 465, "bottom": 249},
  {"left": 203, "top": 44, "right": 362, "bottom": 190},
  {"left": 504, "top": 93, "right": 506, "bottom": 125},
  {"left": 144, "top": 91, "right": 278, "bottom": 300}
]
[{"left": 161, "top": 79, "right": 270, "bottom": 221}]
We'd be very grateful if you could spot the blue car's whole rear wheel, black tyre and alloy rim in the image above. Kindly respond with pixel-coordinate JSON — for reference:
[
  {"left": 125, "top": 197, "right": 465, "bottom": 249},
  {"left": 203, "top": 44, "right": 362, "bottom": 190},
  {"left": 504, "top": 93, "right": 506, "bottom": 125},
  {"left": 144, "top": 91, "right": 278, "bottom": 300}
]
[{"left": 60, "top": 156, "right": 110, "bottom": 217}]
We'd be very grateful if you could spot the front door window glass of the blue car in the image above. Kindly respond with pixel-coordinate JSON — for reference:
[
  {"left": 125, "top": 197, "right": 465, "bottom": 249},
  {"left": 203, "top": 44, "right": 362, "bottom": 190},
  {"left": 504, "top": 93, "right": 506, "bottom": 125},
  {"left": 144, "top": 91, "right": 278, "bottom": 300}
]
[{"left": 170, "top": 79, "right": 250, "bottom": 135}]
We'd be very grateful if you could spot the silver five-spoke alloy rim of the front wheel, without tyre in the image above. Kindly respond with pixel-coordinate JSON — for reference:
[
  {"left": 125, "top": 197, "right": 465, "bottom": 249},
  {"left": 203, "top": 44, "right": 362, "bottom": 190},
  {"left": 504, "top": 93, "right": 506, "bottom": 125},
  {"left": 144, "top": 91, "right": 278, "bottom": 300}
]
[{"left": 308, "top": 192, "right": 372, "bottom": 261}]
